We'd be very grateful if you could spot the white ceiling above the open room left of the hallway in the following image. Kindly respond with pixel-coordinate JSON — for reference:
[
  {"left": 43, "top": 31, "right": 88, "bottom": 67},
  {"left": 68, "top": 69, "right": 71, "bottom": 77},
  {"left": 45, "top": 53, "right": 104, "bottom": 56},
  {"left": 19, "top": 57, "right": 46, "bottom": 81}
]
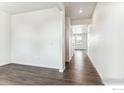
[{"left": 0, "top": 2, "right": 59, "bottom": 14}]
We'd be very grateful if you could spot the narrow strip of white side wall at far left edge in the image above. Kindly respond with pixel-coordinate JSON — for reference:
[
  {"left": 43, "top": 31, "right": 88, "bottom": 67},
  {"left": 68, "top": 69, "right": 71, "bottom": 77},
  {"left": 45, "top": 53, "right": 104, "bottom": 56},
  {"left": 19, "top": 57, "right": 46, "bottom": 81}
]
[{"left": 0, "top": 11, "right": 10, "bottom": 66}]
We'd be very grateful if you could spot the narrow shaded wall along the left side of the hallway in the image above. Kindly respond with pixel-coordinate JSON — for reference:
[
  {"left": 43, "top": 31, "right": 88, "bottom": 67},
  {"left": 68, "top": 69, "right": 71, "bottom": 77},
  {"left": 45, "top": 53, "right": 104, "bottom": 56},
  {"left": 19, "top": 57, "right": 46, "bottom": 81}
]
[{"left": 65, "top": 17, "right": 72, "bottom": 62}]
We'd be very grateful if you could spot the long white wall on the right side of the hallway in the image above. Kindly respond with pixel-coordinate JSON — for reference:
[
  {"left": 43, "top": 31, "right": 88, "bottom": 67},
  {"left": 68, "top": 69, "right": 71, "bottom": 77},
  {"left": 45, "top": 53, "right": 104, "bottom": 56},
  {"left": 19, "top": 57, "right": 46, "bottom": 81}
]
[{"left": 88, "top": 3, "right": 124, "bottom": 82}]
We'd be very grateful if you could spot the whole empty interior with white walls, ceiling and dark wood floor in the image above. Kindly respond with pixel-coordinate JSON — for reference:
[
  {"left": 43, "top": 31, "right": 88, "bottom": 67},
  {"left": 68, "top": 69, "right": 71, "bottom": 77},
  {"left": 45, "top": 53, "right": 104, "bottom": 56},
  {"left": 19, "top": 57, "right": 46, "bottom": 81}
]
[{"left": 0, "top": 2, "right": 124, "bottom": 86}]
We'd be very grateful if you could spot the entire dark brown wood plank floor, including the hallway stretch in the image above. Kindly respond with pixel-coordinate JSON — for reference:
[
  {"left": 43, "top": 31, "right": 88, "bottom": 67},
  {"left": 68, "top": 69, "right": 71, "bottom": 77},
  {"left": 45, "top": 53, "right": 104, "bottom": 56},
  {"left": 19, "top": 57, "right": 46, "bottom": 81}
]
[{"left": 0, "top": 51, "right": 103, "bottom": 85}]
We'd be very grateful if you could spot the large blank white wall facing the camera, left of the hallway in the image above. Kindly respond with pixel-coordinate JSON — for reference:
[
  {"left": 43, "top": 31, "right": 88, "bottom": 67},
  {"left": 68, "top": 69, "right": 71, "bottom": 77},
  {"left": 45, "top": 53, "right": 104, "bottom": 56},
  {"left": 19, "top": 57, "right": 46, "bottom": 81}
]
[{"left": 11, "top": 8, "right": 63, "bottom": 69}]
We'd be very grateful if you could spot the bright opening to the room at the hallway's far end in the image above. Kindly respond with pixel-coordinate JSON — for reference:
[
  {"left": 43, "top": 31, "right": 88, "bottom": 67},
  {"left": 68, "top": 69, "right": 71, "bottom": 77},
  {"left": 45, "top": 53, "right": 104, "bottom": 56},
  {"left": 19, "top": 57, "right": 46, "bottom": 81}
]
[{"left": 72, "top": 25, "right": 88, "bottom": 52}]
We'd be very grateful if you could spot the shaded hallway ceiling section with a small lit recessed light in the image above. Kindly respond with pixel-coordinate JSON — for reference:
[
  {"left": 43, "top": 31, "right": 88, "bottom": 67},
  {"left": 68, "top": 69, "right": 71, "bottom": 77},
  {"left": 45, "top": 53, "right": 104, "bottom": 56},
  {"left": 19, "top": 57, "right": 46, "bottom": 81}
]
[{"left": 64, "top": 2, "right": 96, "bottom": 19}]
